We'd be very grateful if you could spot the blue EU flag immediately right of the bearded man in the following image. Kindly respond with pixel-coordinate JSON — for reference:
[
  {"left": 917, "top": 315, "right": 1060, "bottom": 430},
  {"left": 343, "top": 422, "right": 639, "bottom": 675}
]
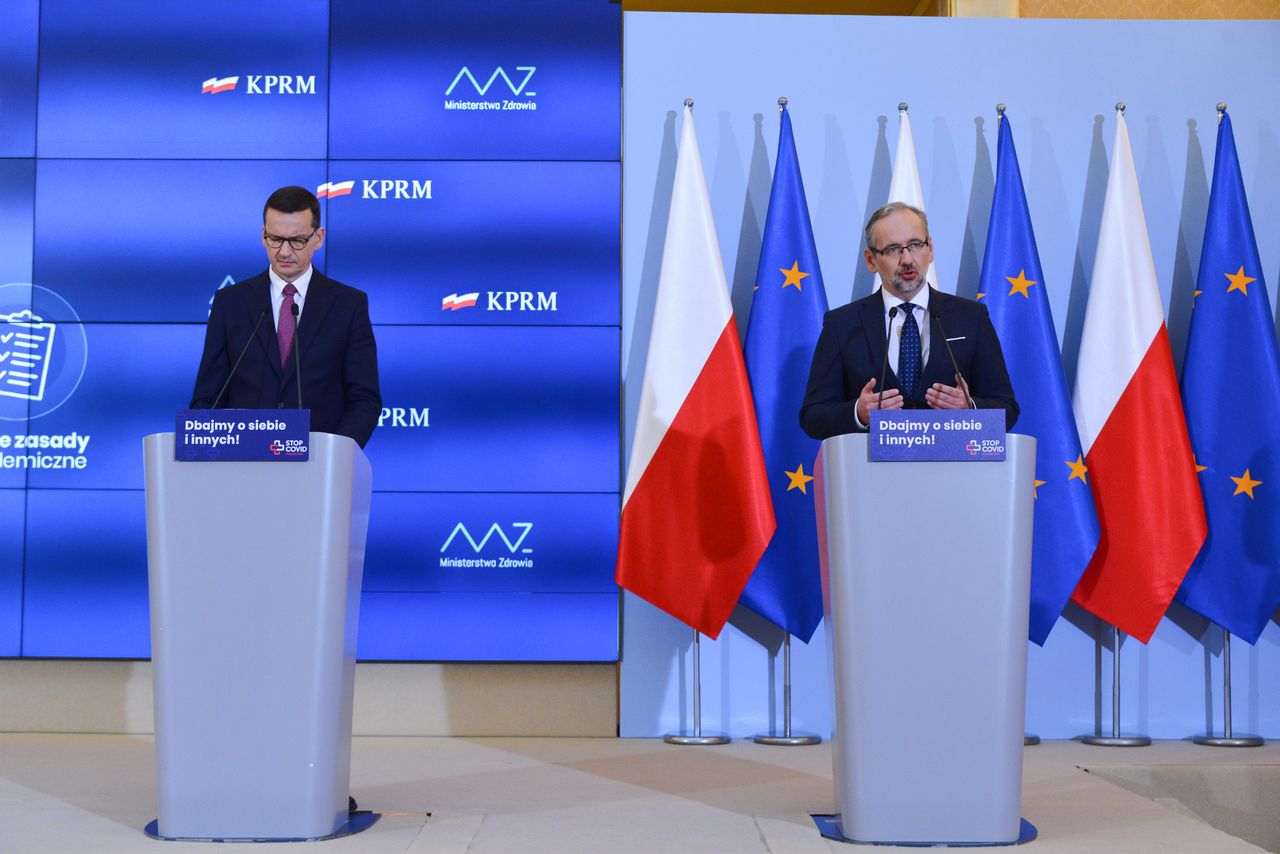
[{"left": 978, "top": 117, "right": 1098, "bottom": 647}]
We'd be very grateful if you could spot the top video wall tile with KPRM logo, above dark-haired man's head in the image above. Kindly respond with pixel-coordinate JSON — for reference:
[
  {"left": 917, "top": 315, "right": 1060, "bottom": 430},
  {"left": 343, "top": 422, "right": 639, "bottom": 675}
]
[{"left": 36, "top": 0, "right": 329, "bottom": 158}]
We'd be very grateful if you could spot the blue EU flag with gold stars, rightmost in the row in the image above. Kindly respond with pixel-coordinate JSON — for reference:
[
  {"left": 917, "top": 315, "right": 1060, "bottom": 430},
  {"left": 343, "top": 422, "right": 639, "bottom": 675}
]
[{"left": 1176, "top": 111, "right": 1280, "bottom": 644}]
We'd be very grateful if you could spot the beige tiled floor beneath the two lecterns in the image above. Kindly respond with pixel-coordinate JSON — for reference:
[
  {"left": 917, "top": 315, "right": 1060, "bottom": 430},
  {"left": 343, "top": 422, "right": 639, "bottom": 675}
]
[{"left": 0, "top": 735, "right": 1280, "bottom": 854}]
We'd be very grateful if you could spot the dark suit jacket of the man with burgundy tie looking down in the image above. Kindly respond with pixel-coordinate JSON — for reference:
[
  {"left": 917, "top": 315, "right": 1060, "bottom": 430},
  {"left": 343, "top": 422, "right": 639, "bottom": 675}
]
[{"left": 191, "top": 270, "right": 383, "bottom": 447}]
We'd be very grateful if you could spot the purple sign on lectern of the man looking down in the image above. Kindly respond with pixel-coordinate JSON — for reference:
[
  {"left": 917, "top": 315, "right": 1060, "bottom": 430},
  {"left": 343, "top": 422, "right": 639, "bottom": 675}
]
[{"left": 173, "top": 410, "right": 311, "bottom": 462}]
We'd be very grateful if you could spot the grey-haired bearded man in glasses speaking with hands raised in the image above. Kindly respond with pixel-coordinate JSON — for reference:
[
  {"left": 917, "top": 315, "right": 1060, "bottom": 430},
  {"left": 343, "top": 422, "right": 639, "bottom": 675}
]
[{"left": 800, "top": 202, "right": 1018, "bottom": 439}]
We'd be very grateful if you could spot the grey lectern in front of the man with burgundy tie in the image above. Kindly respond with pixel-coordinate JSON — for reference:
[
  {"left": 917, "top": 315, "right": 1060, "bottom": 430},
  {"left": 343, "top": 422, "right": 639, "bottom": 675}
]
[{"left": 145, "top": 433, "right": 371, "bottom": 840}]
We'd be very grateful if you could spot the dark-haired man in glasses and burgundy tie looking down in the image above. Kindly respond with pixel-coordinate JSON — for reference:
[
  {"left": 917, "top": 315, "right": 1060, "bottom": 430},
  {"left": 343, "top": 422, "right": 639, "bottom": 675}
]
[{"left": 191, "top": 187, "right": 383, "bottom": 447}]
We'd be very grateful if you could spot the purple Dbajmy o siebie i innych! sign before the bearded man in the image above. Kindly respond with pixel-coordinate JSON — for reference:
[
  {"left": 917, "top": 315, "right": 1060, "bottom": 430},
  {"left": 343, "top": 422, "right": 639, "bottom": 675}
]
[{"left": 867, "top": 410, "right": 1005, "bottom": 462}]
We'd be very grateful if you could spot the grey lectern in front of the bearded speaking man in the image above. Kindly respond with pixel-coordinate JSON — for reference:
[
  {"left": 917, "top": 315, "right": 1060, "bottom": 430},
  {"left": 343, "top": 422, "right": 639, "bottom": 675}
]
[{"left": 819, "top": 434, "right": 1036, "bottom": 845}]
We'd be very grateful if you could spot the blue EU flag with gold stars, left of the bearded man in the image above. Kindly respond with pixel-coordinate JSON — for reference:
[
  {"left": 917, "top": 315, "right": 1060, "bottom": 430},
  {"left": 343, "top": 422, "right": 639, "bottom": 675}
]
[{"left": 741, "top": 108, "right": 827, "bottom": 643}]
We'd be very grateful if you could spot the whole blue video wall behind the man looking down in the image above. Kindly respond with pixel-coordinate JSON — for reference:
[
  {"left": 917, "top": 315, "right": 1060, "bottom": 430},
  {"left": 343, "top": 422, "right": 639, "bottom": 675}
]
[{"left": 0, "top": 0, "right": 621, "bottom": 661}]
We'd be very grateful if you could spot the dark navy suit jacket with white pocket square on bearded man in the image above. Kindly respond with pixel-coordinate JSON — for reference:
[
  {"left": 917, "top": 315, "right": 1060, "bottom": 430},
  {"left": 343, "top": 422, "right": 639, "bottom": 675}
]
[{"left": 800, "top": 288, "right": 1018, "bottom": 439}]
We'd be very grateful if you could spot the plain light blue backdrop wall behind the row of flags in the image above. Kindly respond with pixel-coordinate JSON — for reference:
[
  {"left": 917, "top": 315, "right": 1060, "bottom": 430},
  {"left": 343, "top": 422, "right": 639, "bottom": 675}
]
[{"left": 621, "top": 13, "right": 1280, "bottom": 739}]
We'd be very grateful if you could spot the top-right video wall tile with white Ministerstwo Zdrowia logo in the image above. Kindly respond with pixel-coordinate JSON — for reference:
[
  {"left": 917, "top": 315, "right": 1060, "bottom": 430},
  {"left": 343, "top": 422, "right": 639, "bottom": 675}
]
[{"left": 329, "top": 0, "right": 622, "bottom": 160}]
